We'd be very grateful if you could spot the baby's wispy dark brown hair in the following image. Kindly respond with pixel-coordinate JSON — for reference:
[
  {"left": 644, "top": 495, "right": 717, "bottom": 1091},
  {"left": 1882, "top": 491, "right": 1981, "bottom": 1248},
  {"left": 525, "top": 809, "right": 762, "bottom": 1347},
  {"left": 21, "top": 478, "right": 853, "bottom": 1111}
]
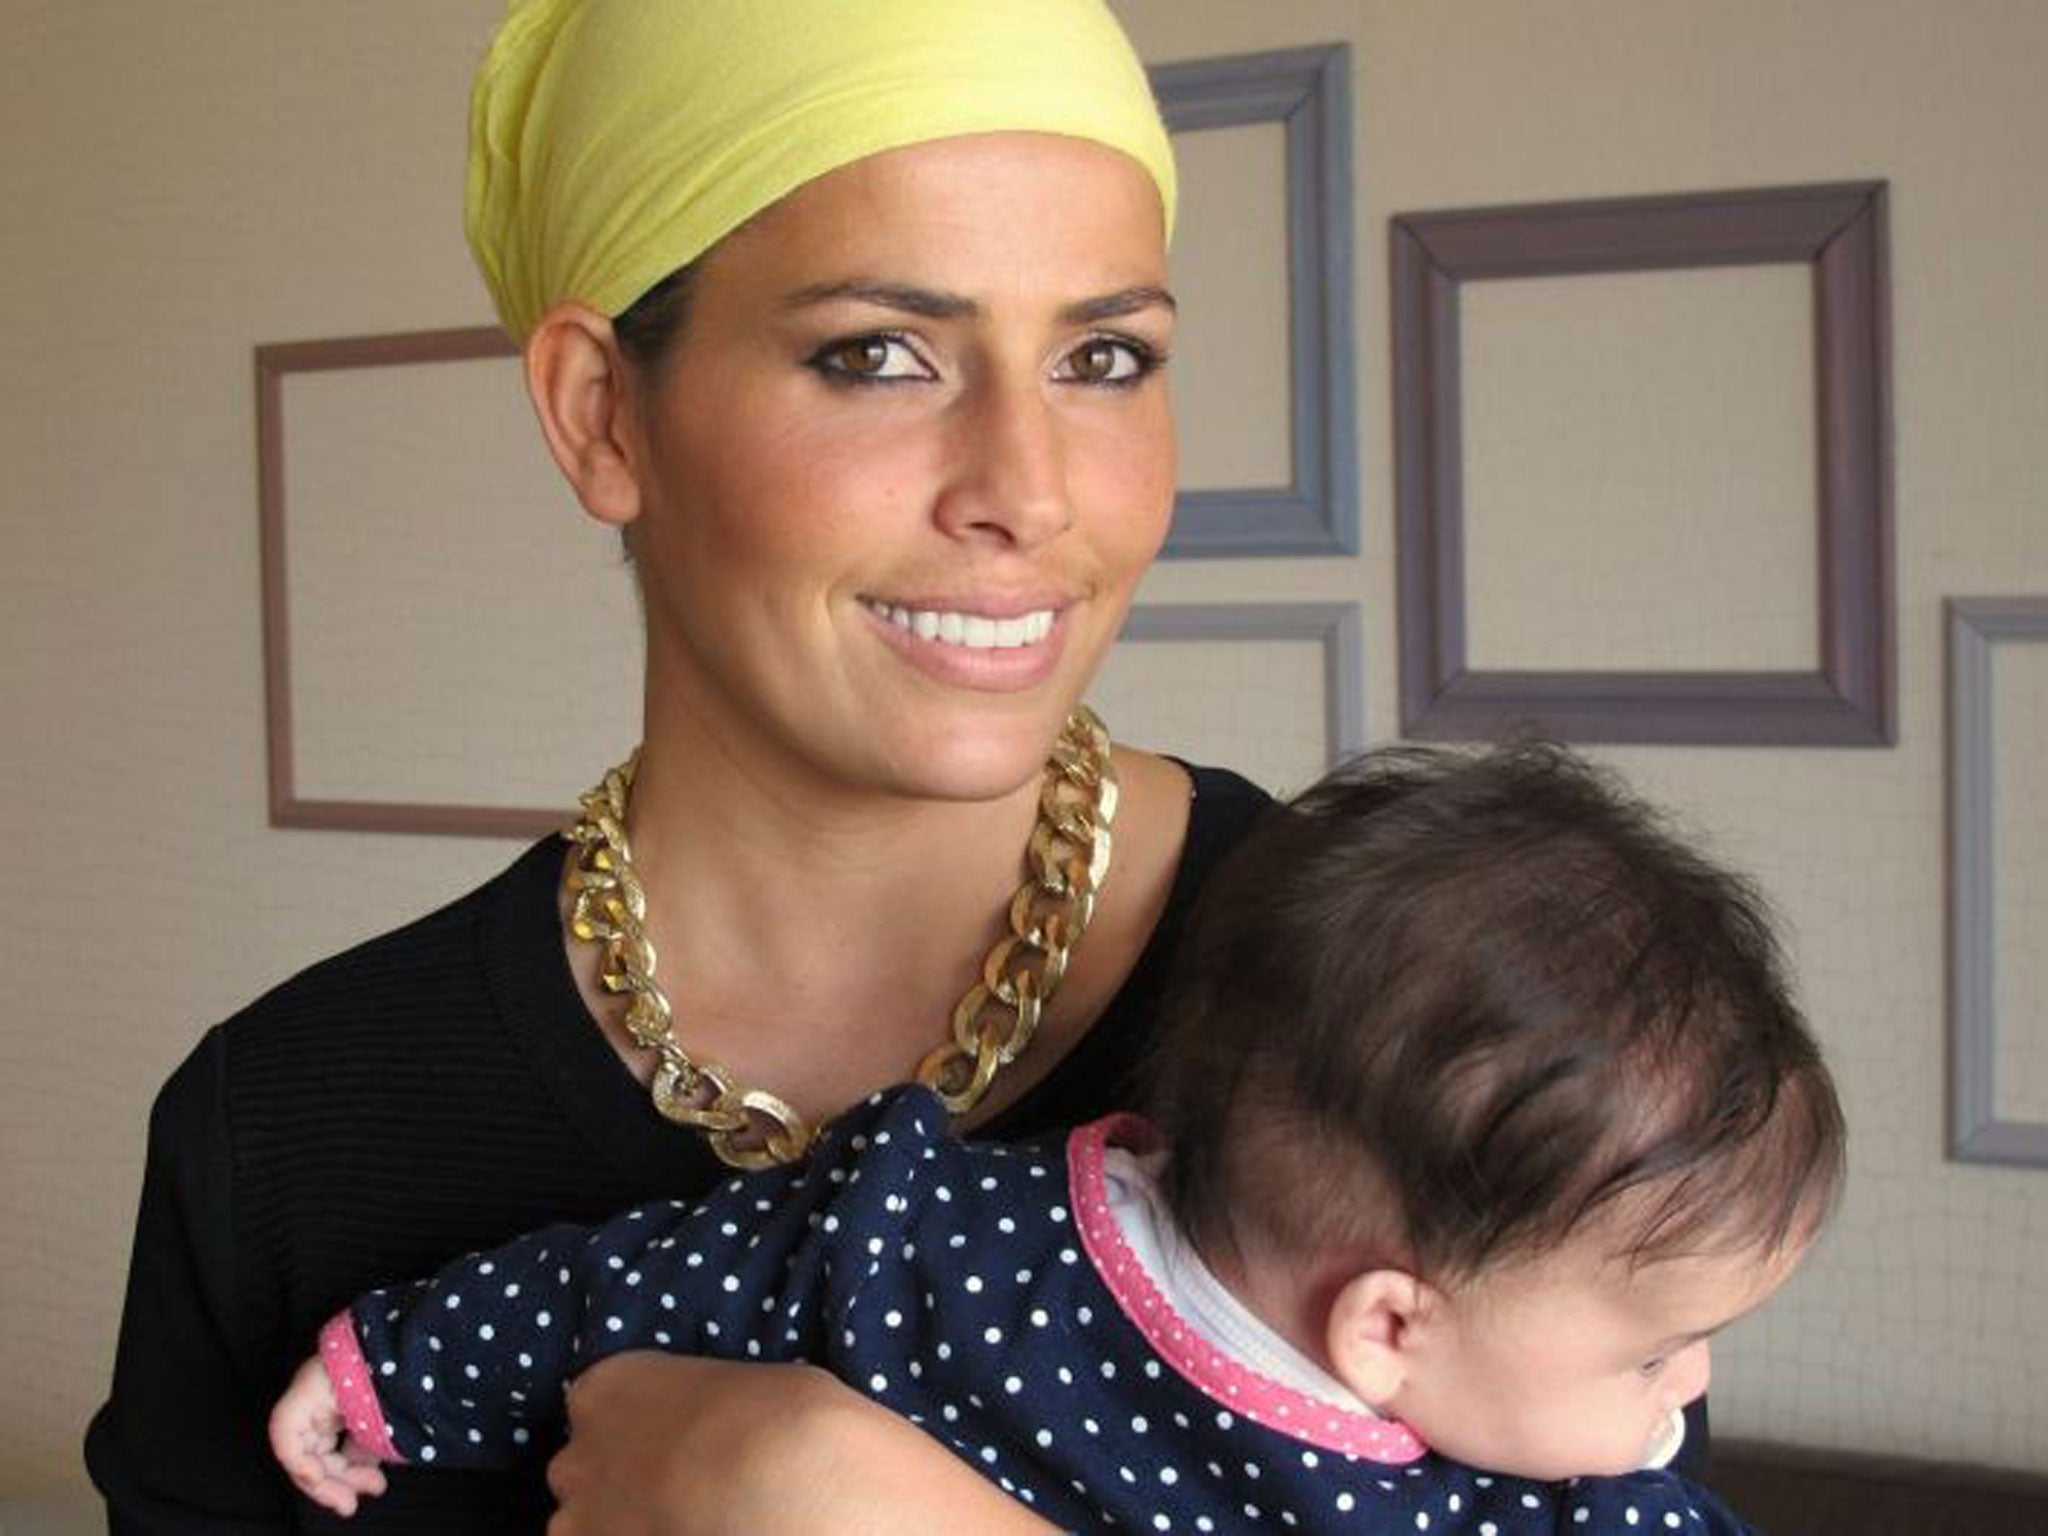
[{"left": 1145, "top": 743, "right": 1843, "bottom": 1282}]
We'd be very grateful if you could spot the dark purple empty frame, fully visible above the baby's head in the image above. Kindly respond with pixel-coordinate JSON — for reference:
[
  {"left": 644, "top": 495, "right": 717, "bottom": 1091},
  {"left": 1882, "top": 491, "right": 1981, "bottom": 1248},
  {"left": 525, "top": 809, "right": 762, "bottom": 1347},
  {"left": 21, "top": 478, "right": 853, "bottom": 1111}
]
[{"left": 1391, "top": 182, "right": 1896, "bottom": 745}]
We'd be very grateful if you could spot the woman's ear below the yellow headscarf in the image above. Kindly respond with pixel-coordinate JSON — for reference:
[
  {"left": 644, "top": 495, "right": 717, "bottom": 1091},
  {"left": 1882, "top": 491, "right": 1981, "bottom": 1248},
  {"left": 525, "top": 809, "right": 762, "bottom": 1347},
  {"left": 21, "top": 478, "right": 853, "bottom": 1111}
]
[{"left": 526, "top": 303, "right": 641, "bottom": 526}]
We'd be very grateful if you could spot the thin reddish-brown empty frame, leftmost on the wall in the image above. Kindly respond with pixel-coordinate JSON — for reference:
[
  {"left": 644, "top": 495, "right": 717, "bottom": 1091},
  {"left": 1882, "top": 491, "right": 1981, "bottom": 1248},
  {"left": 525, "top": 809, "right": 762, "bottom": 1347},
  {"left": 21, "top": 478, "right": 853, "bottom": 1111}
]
[{"left": 256, "top": 326, "right": 571, "bottom": 838}]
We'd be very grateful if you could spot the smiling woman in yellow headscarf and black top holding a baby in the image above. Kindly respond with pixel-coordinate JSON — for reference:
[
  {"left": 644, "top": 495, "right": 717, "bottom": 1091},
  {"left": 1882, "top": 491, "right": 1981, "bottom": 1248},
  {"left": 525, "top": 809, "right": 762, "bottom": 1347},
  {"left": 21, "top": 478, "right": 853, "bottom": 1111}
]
[{"left": 88, "top": 0, "right": 1262, "bottom": 1532}]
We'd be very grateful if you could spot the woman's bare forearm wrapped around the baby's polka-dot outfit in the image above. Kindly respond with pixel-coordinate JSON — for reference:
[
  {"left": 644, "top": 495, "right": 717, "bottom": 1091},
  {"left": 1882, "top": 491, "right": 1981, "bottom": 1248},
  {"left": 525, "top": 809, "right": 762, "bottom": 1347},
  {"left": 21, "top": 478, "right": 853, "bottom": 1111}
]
[{"left": 547, "top": 1354, "right": 1057, "bottom": 1536}]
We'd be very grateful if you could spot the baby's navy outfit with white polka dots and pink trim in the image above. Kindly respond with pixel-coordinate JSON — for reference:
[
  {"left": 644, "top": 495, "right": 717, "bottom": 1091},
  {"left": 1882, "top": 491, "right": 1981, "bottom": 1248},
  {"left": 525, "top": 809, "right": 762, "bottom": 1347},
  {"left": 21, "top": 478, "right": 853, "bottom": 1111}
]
[{"left": 322, "top": 1087, "right": 1747, "bottom": 1536}]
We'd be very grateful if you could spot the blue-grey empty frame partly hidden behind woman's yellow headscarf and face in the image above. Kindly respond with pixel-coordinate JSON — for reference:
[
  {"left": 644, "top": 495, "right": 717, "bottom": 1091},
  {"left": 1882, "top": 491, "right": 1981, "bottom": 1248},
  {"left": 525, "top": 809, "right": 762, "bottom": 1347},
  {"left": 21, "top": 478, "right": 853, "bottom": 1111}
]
[{"left": 1151, "top": 43, "right": 1358, "bottom": 557}]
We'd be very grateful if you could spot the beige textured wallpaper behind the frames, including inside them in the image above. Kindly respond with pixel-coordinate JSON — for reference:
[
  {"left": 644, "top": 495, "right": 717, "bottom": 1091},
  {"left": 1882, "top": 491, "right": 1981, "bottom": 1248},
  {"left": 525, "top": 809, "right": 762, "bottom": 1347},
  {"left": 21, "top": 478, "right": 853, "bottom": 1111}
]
[{"left": 0, "top": 0, "right": 2048, "bottom": 1495}]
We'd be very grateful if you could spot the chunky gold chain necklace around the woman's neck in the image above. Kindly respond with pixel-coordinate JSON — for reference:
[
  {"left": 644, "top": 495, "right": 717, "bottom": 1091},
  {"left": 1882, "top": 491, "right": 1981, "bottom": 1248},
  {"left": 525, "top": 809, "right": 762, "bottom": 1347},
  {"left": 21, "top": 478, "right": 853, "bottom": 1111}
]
[{"left": 561, "top": 705, "right": 1116, "bottom": 1167}]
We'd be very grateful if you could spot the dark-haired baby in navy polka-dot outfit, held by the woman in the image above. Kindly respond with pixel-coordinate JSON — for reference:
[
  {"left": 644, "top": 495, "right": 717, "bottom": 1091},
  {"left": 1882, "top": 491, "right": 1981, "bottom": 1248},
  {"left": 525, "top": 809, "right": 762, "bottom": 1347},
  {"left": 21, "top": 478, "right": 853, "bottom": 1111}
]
[{"left": 270, "top": 745, "right": 1843, "bottom": 1536}]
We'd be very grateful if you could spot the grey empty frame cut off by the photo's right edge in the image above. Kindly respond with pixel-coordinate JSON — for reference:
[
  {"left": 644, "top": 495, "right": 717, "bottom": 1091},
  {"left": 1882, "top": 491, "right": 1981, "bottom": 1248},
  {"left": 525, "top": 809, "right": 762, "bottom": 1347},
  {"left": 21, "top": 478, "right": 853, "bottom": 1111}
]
[{"left": 1948, "top": 596, "right": 2048, "bottom": 1167}]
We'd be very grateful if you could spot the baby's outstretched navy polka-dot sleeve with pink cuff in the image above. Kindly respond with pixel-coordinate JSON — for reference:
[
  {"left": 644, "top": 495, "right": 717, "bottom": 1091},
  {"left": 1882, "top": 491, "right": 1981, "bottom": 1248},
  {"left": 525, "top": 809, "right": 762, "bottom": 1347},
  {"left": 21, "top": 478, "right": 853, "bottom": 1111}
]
[{"left": 322, "top": 1090, "right": 944, "bottom": 1468}]
